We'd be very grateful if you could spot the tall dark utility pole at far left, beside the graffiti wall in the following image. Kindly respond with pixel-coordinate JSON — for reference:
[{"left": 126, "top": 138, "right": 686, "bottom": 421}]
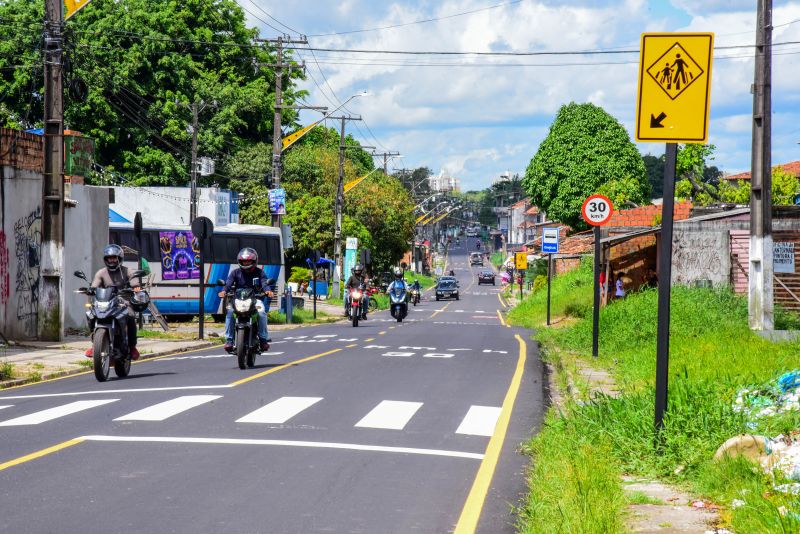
[{"left": 37, "top": 0, "right": 64, "bottom": 341}]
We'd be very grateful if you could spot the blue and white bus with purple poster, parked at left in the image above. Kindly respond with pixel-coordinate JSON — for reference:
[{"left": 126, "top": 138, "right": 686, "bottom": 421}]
[{"left": 109, "top": 222, "right": 284, "bottom": 318}]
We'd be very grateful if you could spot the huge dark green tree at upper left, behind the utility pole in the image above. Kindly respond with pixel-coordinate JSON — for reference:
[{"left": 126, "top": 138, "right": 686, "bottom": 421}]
[{"left": 0, "top": 0, "right": 304, "bottom": 185}]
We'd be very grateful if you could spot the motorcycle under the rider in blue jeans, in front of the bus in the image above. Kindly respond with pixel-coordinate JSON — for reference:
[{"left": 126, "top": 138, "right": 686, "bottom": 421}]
[{"left": 217, "top": 279, "right": 275, "bottom": 369}]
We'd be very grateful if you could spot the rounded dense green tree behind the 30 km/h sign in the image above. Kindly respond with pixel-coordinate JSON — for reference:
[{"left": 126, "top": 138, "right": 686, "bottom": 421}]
[{"left": 522, "top": 103, "right": 650, "bottom": 229}]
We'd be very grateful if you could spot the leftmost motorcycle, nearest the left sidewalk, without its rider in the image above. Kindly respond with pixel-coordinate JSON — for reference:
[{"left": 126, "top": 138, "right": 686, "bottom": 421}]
[{"left": 73, "top": 271, "right": 150, "bottom": 382}]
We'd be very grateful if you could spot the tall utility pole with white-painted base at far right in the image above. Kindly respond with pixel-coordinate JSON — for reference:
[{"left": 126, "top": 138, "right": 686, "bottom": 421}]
[{"left": 748, "top": 0, "right": 775, "bottom": 330}]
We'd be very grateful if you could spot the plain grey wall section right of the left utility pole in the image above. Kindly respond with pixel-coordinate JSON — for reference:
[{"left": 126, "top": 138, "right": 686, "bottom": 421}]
[{"left": 64, "top": 184, "right": 109, "bottom": 329}]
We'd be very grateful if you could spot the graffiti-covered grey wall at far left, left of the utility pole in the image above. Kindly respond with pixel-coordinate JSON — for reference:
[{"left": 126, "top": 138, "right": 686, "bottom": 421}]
[{"left": 0, "top": 166, "right": 42, "bottom": 339}]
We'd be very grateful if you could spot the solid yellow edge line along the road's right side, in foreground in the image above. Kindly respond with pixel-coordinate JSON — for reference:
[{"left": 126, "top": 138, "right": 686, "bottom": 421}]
[{"left": 453, "top": 334, "right": 528, "bottom": 534}]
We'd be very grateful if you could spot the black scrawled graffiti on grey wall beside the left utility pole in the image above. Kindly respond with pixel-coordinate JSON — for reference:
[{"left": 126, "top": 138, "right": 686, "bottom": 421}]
[{"left": 14, "top": 207, "right": 42, "bottom": 328}]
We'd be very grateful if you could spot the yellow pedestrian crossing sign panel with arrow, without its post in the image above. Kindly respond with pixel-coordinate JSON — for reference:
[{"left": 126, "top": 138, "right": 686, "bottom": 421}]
[{"left": 636, "top": 33, "right": 714, "bottom": 143}]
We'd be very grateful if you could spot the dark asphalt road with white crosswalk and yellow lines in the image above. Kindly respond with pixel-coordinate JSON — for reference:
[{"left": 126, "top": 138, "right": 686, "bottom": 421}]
[{"left": 0, "top": 240, "right": 545, "bottom": 534}]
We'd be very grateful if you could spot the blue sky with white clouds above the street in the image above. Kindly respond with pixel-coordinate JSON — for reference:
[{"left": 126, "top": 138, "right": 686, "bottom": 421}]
[{"left": 237, "top": 0, "right": 800, "bottom": 190}]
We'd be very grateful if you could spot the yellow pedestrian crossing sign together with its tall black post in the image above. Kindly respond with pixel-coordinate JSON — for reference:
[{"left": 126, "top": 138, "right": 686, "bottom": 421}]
[{"left": 636, "top": 33, "right": 714, "bottom": 435}]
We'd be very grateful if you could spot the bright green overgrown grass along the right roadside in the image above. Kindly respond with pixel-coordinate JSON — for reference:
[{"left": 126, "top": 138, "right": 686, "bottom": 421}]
[{"left": 509, "top": 263, "right": 800, "bottom": 533}]
